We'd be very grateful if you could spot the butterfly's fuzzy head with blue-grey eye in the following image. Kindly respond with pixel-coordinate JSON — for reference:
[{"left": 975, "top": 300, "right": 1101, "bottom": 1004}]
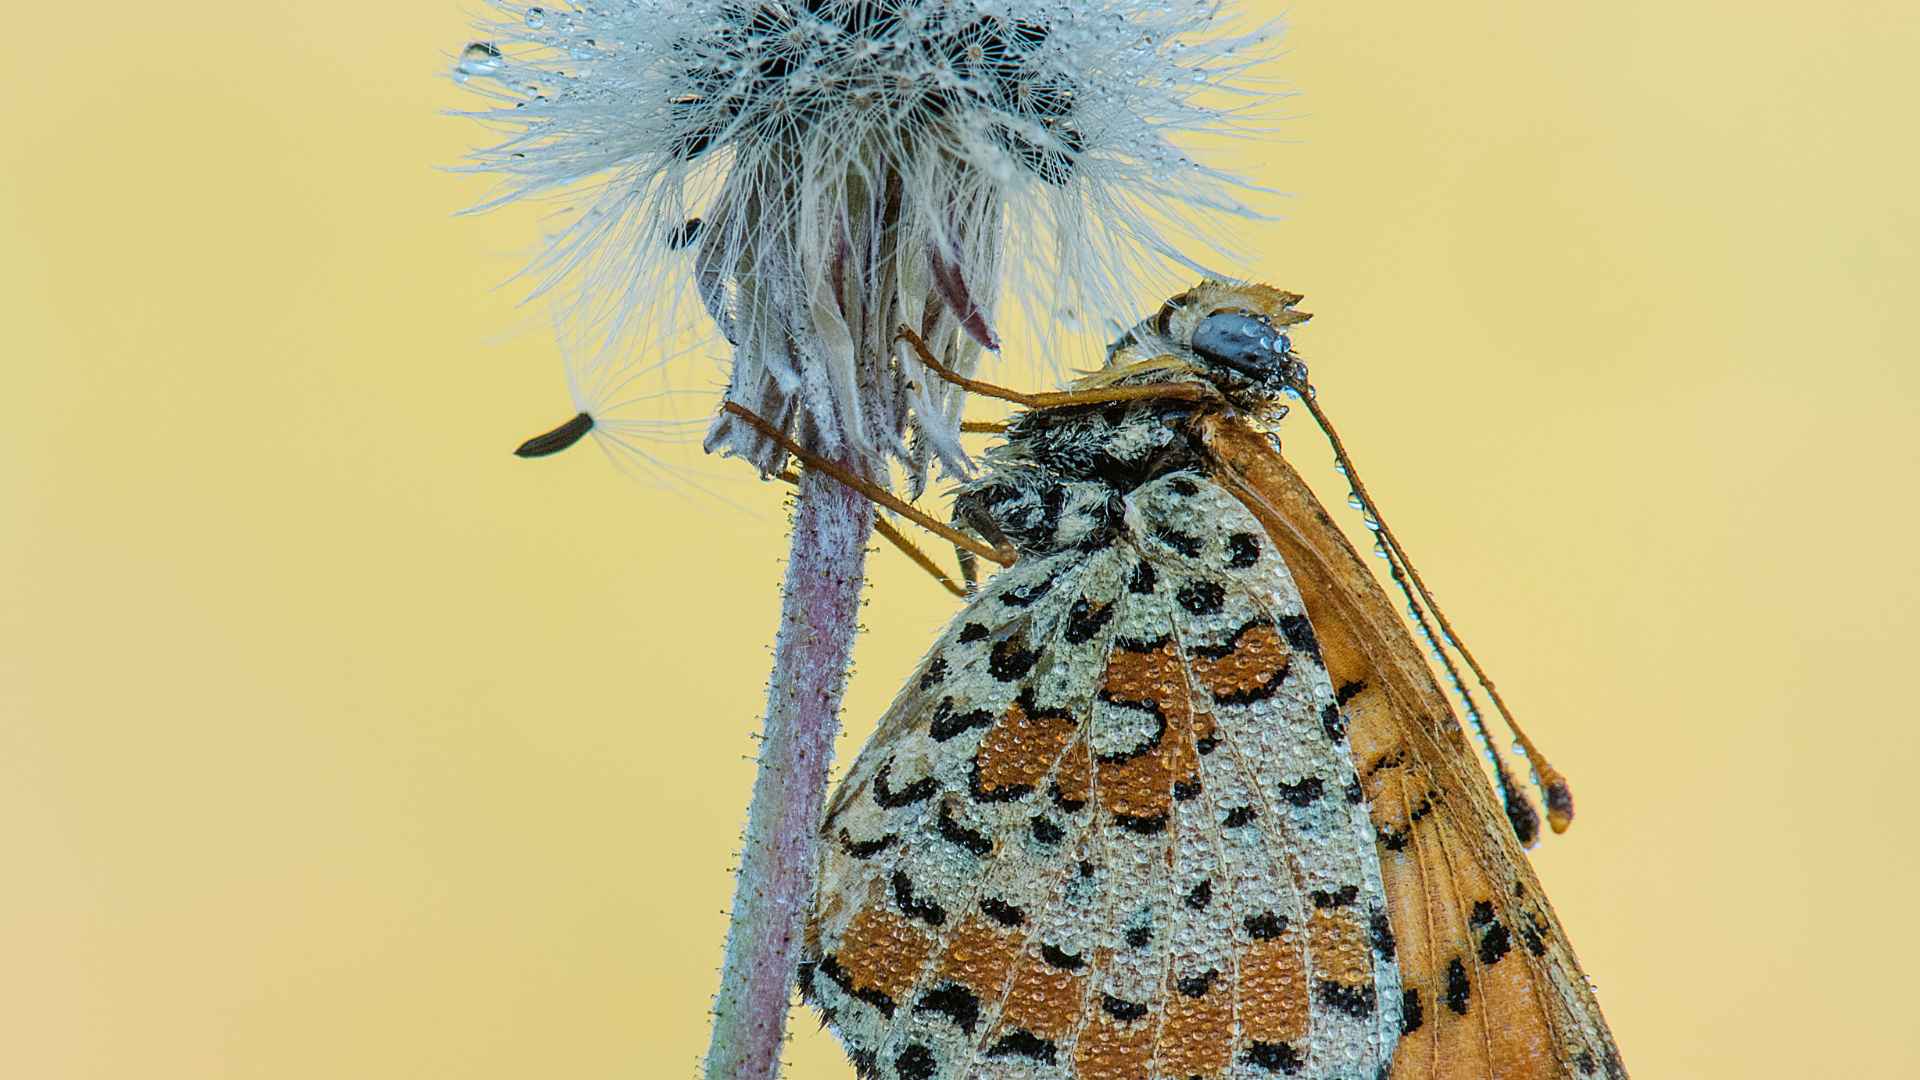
[{"left": 1108, "top": 281, "right": 1309, "bottom": 409}]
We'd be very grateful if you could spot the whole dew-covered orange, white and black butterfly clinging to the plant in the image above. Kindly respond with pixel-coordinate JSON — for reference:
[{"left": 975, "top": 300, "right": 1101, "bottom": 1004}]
[{"left": 748, "top": 282, "right": 1626, "bottom": 1080}]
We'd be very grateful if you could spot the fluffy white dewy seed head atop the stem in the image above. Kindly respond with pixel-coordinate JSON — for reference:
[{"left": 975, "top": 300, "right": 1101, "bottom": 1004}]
[{"left": 455, "top": 0, "right": 1273, "bottom": 480}]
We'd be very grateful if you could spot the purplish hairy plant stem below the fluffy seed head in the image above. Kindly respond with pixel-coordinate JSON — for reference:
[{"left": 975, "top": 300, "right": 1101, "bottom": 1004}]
[{"left": 707, "top": 469, "right": 874, "bottom": 1080}]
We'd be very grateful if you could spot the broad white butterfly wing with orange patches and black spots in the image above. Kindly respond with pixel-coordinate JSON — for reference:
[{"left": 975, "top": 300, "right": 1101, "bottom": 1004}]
[{"left": 801, "top": 475, "right": 1402, "bottom": 1080}]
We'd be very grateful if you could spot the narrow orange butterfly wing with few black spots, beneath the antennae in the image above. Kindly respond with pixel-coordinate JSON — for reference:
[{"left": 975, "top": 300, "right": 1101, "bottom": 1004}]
[{"left": 1200, "top": 417, "right": 1626, "bottom": 1080}]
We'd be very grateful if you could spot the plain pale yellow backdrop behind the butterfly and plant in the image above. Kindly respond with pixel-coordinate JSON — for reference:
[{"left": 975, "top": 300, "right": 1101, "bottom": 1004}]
[{"left": 0, "top": 0, "right": 1920, "bottom": 1080}]
